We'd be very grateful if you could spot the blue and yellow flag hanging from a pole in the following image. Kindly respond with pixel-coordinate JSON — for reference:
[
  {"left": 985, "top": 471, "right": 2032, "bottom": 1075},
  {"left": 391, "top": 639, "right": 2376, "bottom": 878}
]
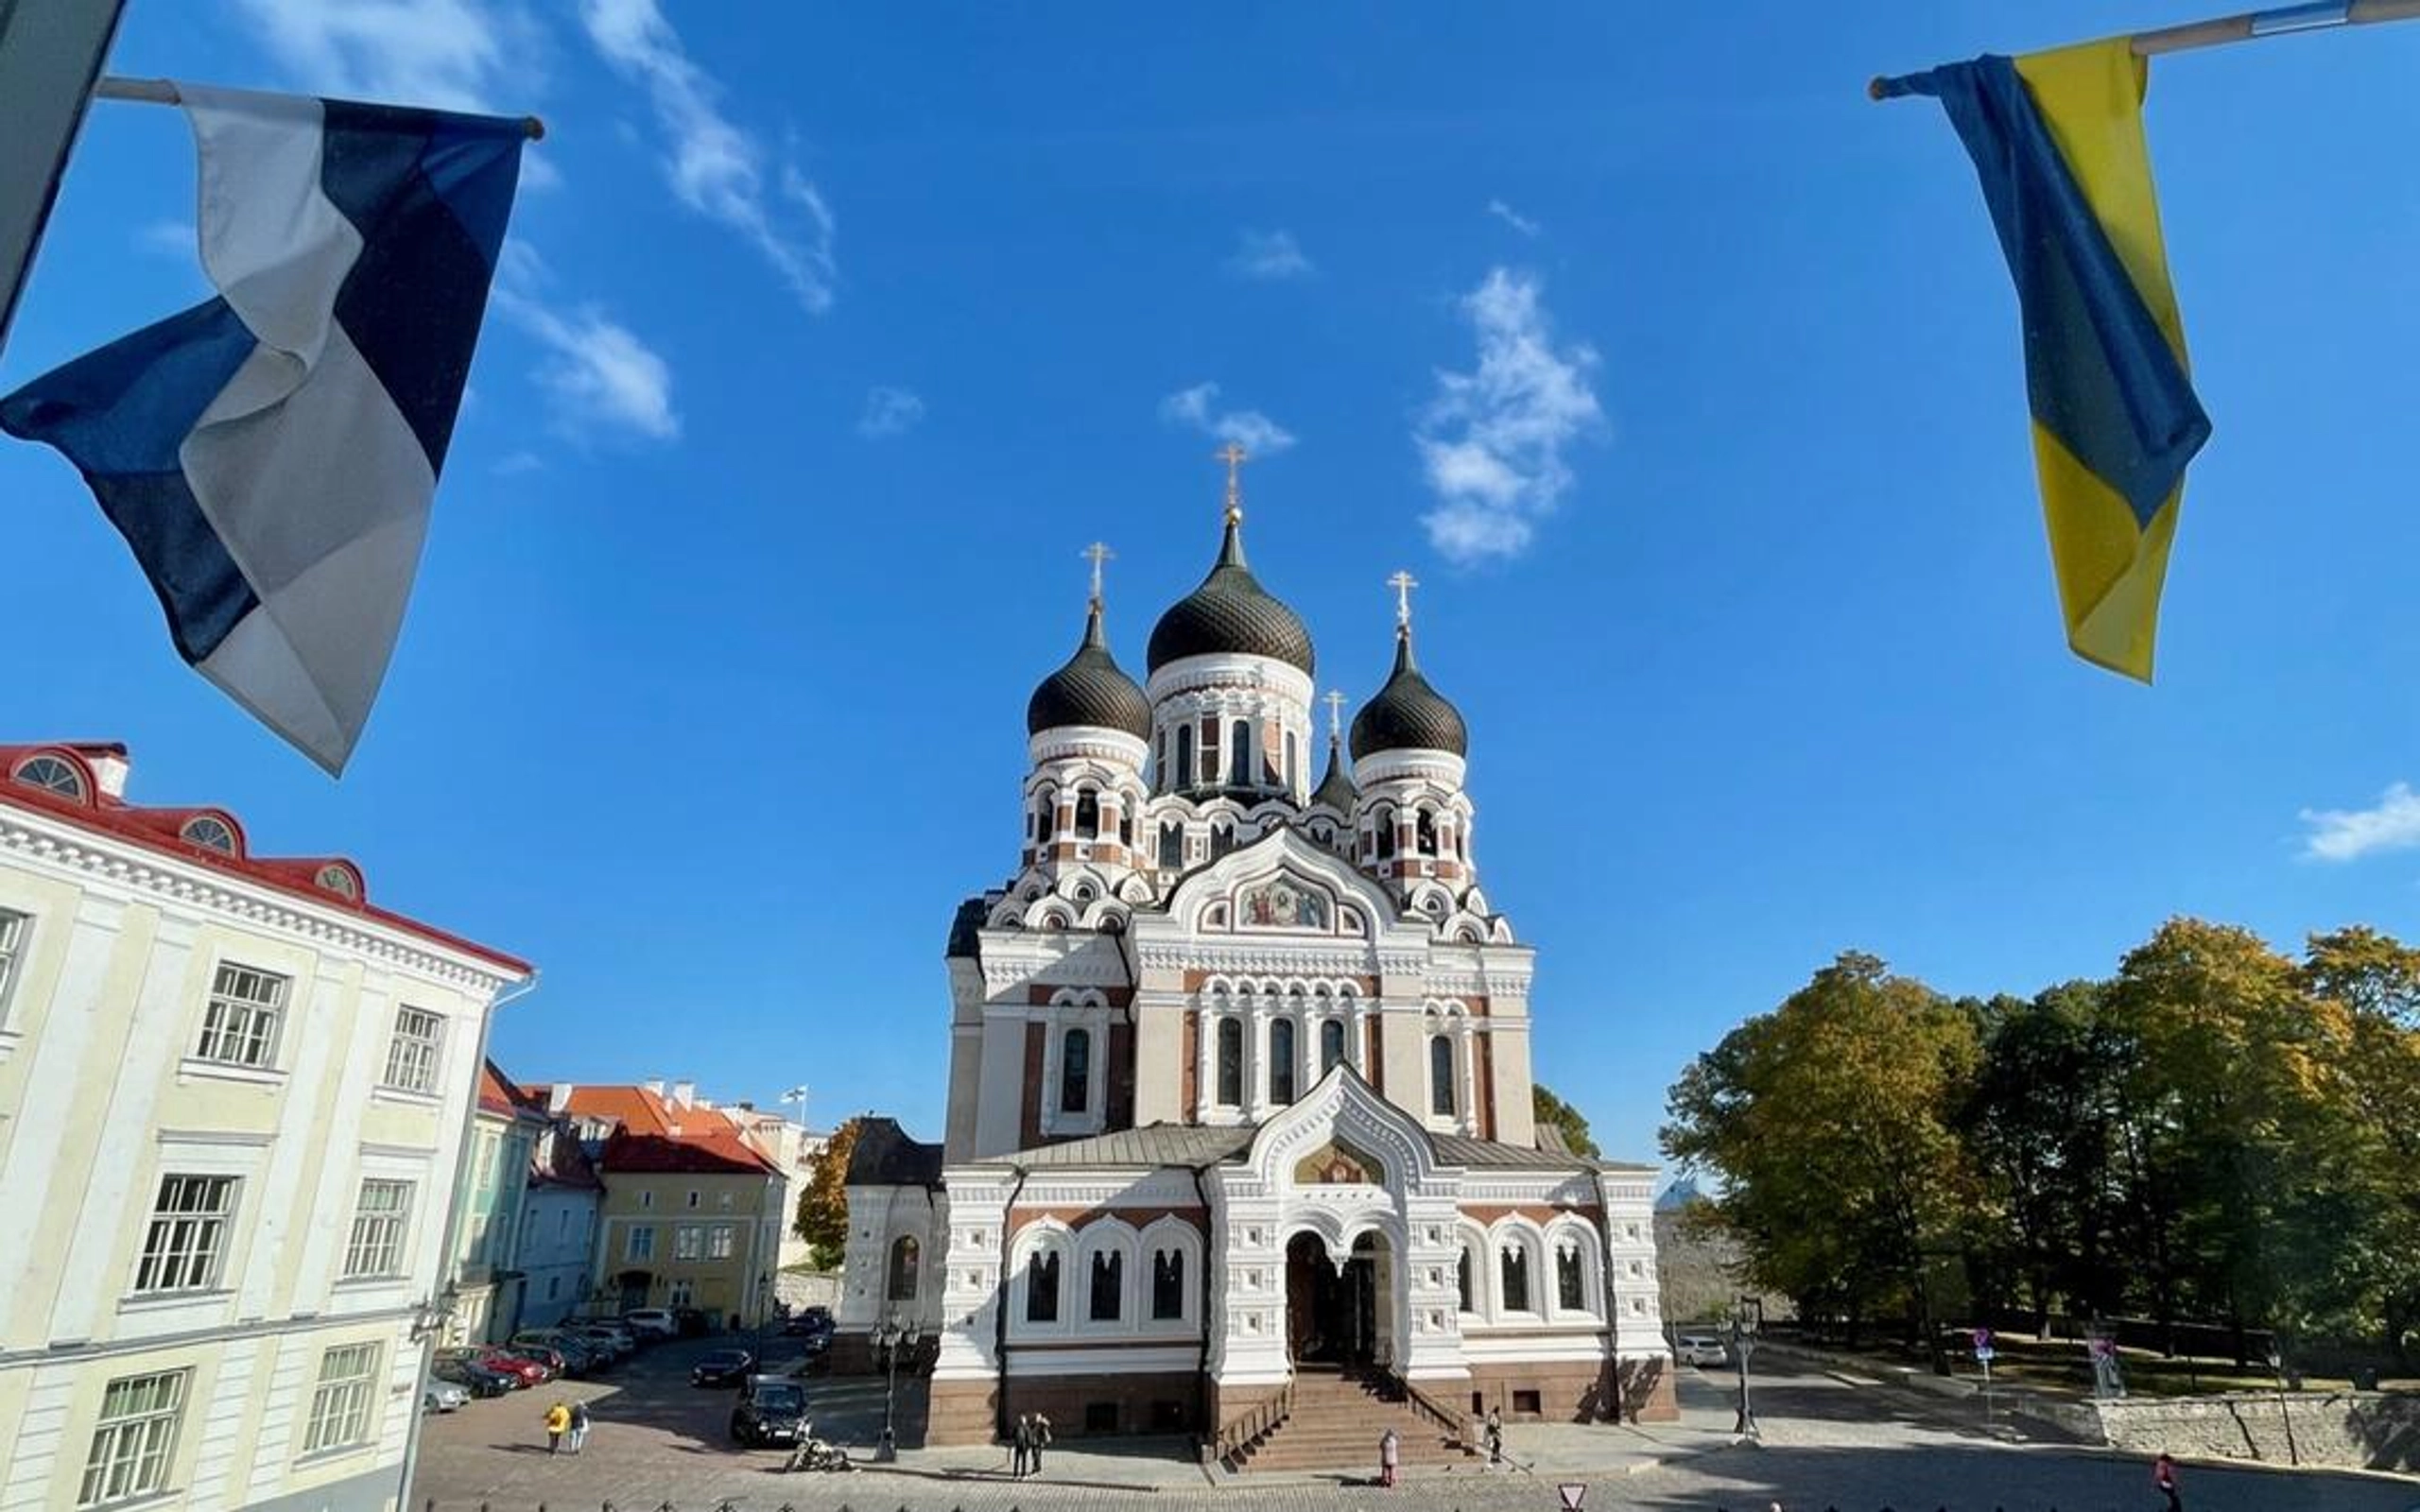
[{"left": 1878, "top": 36, "right": 2209, "bottom": 682}]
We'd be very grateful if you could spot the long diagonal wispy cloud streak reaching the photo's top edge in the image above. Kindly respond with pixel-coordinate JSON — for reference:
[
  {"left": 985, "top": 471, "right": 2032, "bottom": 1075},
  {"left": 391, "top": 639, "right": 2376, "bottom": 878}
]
[{"left": 580, "top": 0, "right": 838, "bottom": 315}]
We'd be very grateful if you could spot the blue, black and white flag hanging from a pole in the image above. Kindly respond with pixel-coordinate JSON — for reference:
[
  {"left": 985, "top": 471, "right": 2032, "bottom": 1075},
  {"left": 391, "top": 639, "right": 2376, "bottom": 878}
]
[{"left": 0, "top": 85, "right": 526, "bottom": 774}]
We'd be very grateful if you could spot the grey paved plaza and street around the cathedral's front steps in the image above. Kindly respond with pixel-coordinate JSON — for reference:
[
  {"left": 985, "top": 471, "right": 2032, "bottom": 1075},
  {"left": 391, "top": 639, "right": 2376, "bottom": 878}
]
[{"left": 411, "top": 1343, "right": 2420, "bottom": 1512}]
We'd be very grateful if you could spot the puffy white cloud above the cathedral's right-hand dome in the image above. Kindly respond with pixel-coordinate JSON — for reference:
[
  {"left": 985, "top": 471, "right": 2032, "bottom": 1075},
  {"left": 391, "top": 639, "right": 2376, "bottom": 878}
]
[{"left": 1413, "top": 268, "right": 1604, "bottom": 563}]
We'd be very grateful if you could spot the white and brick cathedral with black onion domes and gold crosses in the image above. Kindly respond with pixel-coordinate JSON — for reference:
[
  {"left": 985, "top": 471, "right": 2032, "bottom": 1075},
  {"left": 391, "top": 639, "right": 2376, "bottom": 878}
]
[{"left": 838, "top": 448, "right": 1672, "bottom": 1461}]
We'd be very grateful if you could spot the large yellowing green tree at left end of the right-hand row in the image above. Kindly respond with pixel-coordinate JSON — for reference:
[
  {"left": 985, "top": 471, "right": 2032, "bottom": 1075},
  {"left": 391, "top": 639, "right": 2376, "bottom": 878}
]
[{"left": 1663, "top": 954, "right": 1979, "bottom": 1372}]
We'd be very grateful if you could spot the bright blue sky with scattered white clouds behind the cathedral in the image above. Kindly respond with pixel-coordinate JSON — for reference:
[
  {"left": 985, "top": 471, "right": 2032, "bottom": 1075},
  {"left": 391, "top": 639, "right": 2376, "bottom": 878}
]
[{"left": 0, "top": 0, "right": 2420, "bottom": 1159}]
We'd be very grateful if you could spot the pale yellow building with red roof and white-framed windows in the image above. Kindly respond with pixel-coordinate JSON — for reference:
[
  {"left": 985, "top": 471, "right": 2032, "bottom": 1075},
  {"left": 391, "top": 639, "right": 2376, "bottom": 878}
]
[{"left": 0, "top": 745, "right": 530, "bottom": 1512}]
